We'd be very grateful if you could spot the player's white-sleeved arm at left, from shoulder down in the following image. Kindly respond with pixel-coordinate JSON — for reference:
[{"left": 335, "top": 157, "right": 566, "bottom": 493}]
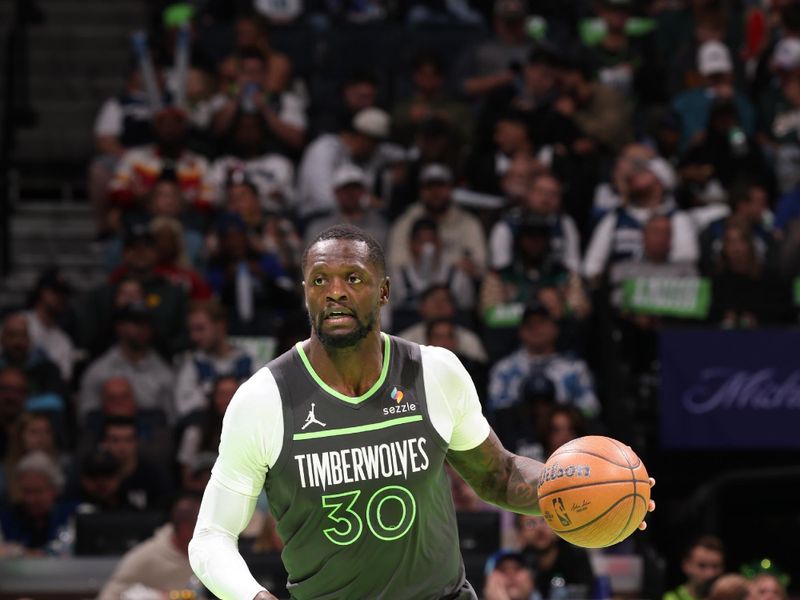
[{"left": 189, "top": 368, "right": 283, "bottom": 600}]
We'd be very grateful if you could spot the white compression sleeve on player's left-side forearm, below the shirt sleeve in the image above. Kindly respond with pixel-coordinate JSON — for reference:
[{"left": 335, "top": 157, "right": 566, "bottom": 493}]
[{"left": 189, "top": 475, "right": 264, "bottom": 600}]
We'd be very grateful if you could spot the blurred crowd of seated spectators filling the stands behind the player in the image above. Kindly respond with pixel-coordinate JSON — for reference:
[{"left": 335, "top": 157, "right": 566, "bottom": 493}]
[{"left": 0, "top": 0, "right": 800, "bottom": 600}]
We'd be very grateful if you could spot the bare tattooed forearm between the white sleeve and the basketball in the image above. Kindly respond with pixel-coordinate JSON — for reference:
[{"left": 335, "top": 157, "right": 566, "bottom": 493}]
[{"left": 447, "top": 431, "right": 544, "bottom": 515}]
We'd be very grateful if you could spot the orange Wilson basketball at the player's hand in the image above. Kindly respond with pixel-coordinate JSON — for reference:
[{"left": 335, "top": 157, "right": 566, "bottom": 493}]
[{"left": 538, "top": 435, "right": 650, "bottom": 548}]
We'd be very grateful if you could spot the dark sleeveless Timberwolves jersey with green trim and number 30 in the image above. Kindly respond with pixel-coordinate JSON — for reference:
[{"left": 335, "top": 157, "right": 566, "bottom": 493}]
[{"left": 265, "top": 335, "right": 476, "bottom": 600}]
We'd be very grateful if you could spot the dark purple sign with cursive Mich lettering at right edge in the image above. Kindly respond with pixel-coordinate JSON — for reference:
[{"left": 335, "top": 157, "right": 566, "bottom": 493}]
[{"left": 660, "top": 329, "right": 800, "bottom": 448}]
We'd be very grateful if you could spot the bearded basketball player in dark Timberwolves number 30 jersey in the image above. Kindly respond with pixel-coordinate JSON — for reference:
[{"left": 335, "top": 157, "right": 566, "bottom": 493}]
[{"left": 189, "top": 225, "right": 654, "bottom": 600}]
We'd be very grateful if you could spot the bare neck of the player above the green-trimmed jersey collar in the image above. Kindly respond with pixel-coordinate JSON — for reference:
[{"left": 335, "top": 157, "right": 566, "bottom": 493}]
[{"left": 305, "top": 328, "right": 383, "bottom": 397}]
